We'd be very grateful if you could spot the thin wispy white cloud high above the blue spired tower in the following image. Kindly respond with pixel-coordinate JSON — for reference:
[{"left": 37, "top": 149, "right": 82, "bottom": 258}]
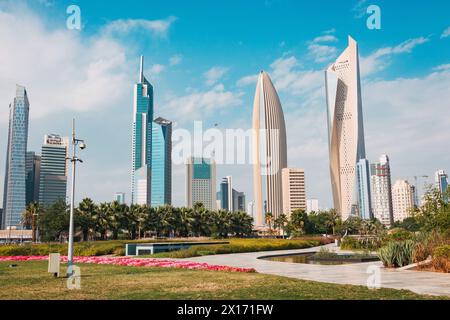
[{"left": 103, "top": 16, "right": 177, "bottom": 37}]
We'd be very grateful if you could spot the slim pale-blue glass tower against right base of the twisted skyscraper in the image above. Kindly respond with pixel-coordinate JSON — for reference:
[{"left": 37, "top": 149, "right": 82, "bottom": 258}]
[{"left": 356, "top": 159, "right": 373, "bottom": 220}]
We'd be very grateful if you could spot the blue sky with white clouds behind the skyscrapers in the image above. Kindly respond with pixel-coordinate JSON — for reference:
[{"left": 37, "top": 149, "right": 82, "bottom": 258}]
[{"left": 0, "top": 0, "right": 450, "bottom": 207}]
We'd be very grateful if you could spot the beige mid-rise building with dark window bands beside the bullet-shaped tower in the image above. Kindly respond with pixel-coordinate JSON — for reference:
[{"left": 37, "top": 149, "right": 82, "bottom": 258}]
[{"left": 282, "top": 168, "right": 307, "bottom": 216}]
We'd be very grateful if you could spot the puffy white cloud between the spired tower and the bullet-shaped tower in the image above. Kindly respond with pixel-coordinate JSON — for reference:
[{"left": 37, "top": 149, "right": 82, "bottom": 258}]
[{"left": 164, "top": 84, "right": 243, "bottom": 121}]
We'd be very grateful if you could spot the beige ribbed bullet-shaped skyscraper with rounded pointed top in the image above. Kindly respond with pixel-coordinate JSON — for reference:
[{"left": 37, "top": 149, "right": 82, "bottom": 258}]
[{"left": 252, "top": 71, "right": 287, "bottom": 227}]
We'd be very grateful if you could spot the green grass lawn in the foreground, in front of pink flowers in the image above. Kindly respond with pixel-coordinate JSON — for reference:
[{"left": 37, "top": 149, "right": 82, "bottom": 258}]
[{"left": 0, "top": 261, "right": 444, "bottom": 300}]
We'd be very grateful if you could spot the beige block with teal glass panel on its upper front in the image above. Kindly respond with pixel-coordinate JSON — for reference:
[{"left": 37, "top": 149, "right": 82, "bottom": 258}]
[{"left": 186, "top": 157, "right": 217, "bottom": 210}]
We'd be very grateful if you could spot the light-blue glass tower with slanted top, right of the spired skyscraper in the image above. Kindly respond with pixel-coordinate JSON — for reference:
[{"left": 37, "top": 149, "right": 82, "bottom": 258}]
[{"left": 151, "top": 118, "right": 172, "bottom": 207}]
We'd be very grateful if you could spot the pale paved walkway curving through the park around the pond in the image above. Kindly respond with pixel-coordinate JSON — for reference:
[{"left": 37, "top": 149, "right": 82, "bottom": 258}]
[{"left": 187, "top": 244, "right": 450, "bottom": 297}]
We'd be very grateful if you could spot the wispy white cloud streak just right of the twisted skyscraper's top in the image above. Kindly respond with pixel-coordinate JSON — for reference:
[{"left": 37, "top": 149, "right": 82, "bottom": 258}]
[{"left": 361, "top": 37, "right": 430, "bottom": 77}]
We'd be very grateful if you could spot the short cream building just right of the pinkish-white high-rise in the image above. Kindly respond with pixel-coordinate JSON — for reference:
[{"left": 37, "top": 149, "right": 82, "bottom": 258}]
[{"left": 392, "top": 180, "right": 414, "bottom": 222}]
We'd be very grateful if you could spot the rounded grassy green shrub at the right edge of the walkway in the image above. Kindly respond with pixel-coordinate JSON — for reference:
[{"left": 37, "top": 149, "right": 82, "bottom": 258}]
[{"left": 378, "top": 240, "right": 416, "bottom": 268}]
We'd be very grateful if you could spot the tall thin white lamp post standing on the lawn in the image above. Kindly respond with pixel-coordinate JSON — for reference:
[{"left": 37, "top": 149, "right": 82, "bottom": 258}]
[{"left": 67, "top": 119, "right": 86, "bottom": 277}]
